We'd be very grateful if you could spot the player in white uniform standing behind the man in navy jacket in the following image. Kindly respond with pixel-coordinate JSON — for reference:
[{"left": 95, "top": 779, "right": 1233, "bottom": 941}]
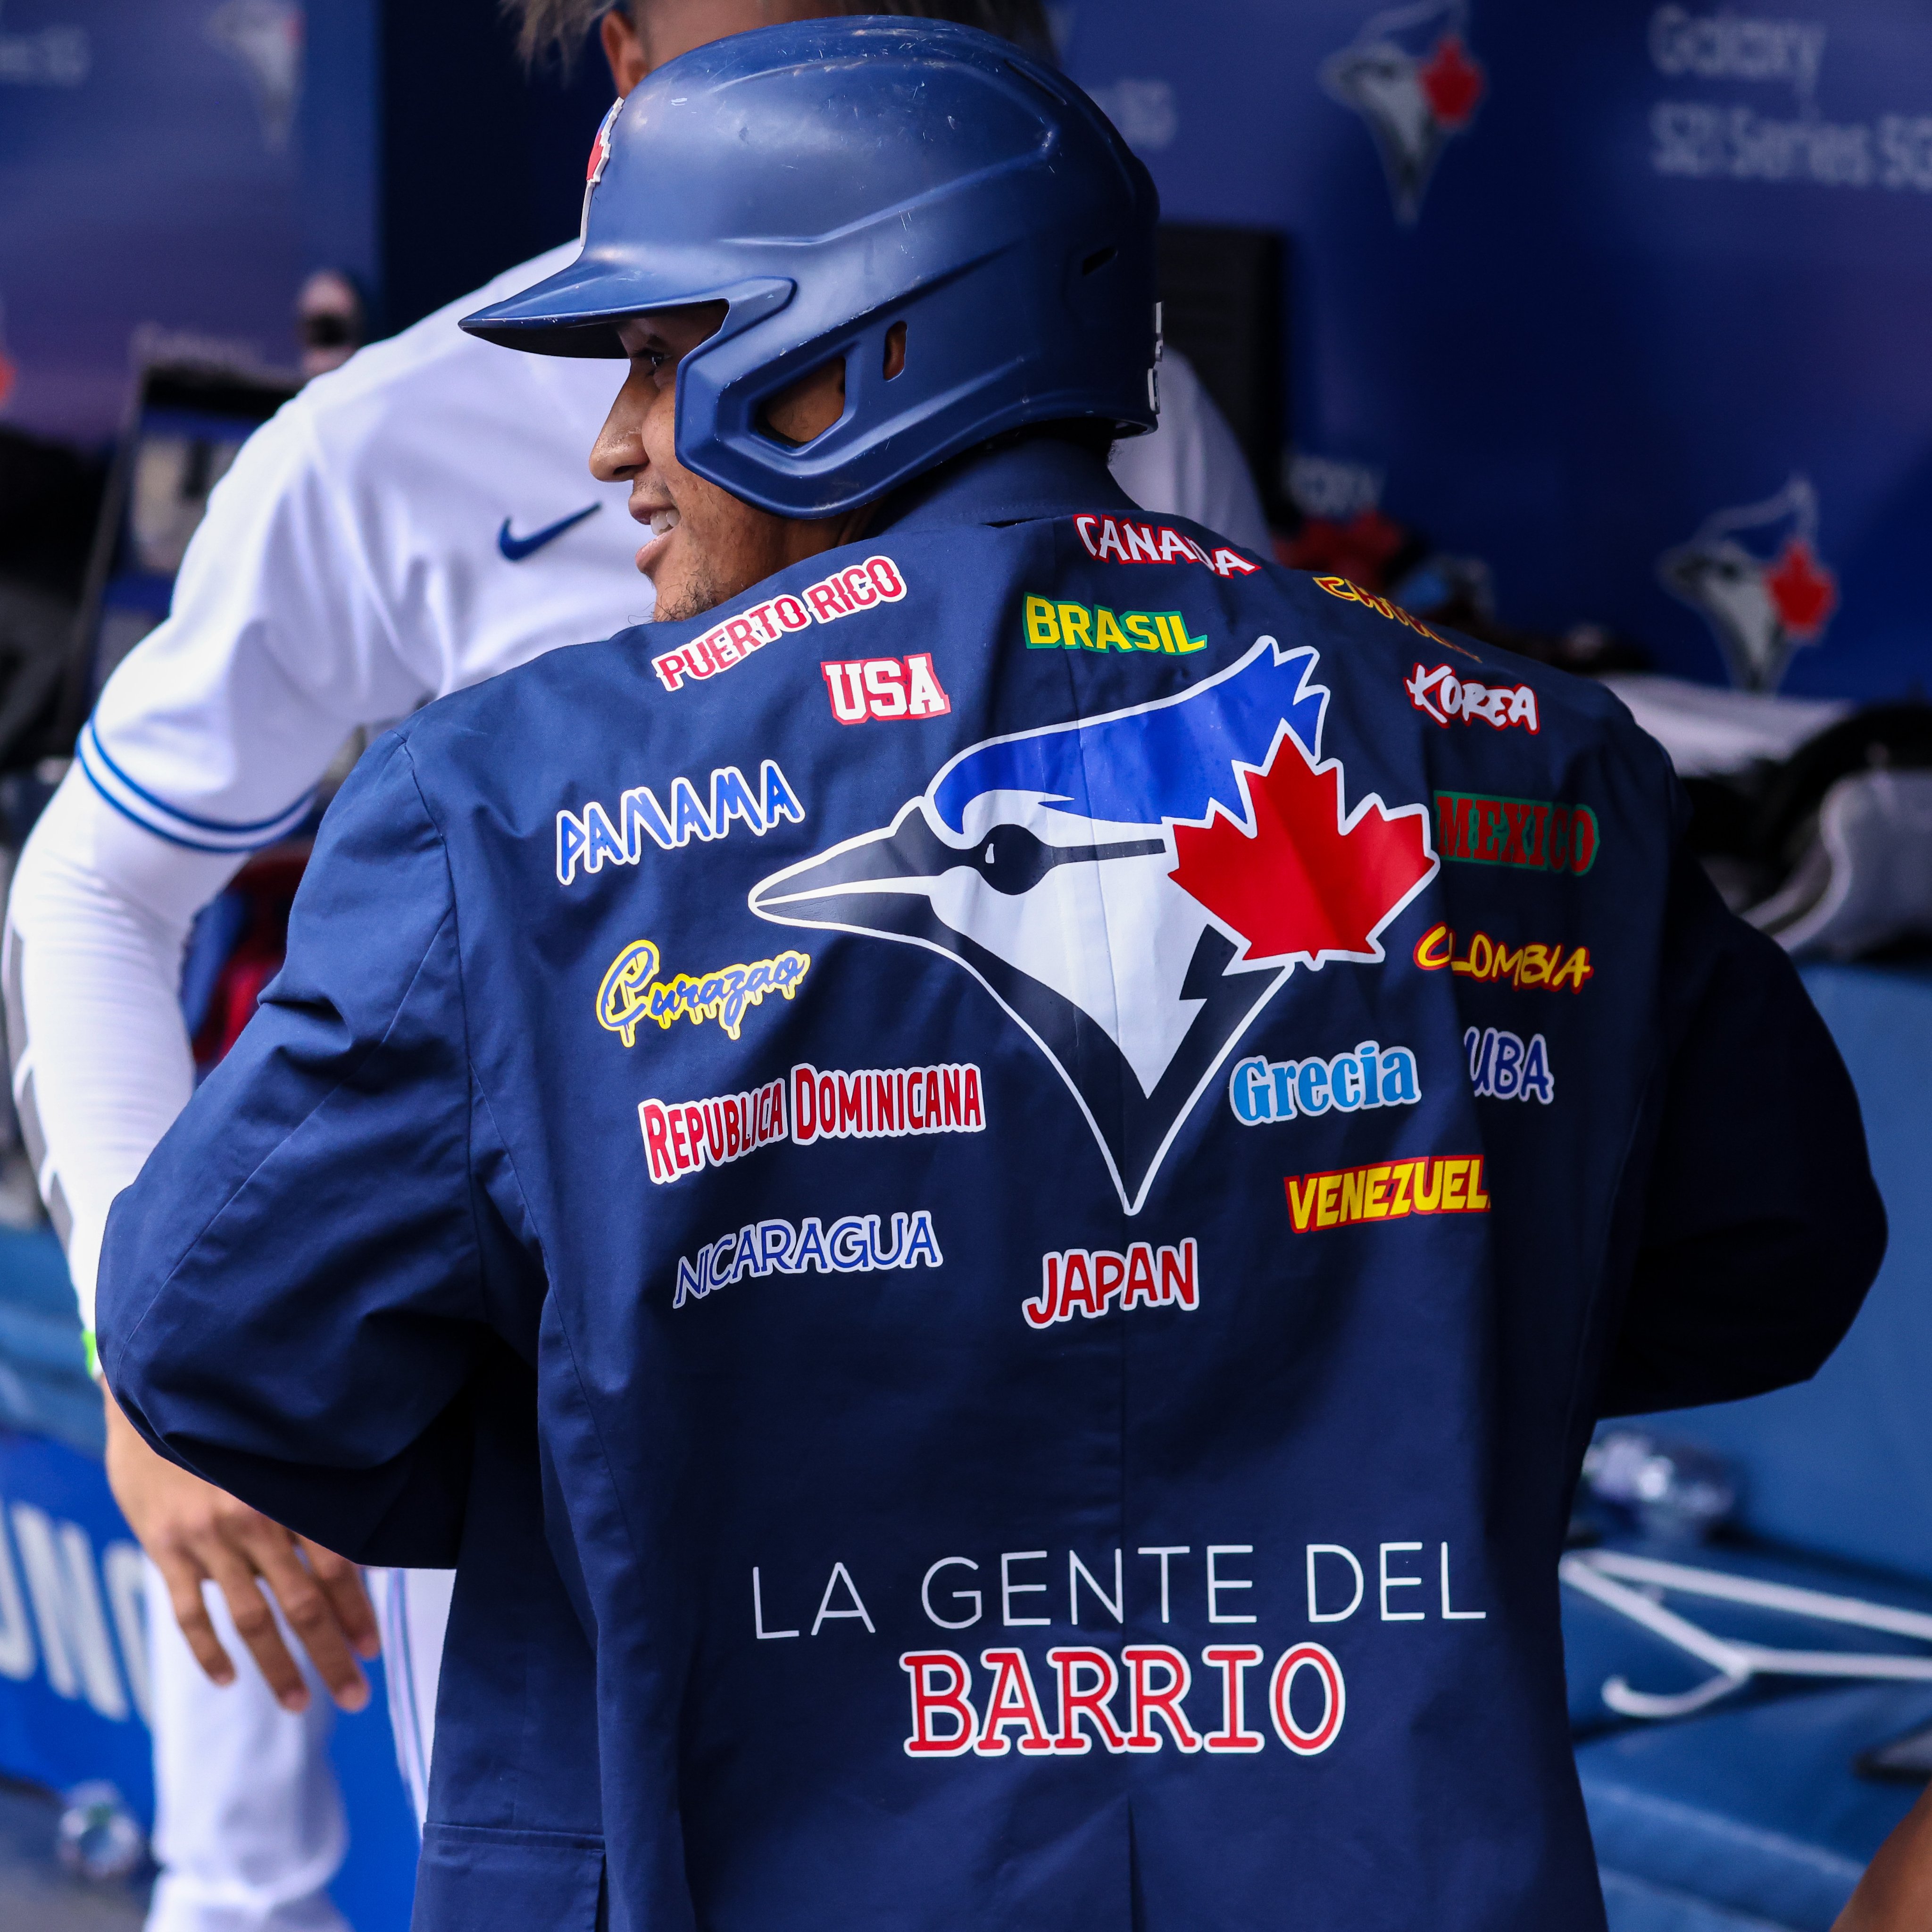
[{"left": 6, "top": 0, "right": 1266, "bottom": 1932}]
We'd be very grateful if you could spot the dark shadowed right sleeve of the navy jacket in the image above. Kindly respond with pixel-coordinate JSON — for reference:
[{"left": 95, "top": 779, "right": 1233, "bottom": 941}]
[{"left": 1598, "top": 852, "right": 1886, "bottom": 1414}]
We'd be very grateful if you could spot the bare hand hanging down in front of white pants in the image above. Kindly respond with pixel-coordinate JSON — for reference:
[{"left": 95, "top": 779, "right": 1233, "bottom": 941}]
[{"left": 100, "top": 1389, "right": 381, "bottom": 1710}]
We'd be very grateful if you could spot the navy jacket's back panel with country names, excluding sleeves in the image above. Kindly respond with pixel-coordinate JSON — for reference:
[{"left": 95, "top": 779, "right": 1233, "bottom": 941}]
[{"left": 411, "top": 510, "right": 1671, "bottom": 1932}]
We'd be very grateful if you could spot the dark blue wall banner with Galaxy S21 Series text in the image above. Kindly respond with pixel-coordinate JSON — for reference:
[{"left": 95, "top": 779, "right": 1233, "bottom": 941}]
[{"left": 1049, "top": 0, "right": 1932, "bottom": 698}]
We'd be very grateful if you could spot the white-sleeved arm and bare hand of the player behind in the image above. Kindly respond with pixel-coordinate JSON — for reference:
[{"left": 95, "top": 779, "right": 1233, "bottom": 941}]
[{"left": 4, "top": 406, "right": 423, "bottom": 1706}]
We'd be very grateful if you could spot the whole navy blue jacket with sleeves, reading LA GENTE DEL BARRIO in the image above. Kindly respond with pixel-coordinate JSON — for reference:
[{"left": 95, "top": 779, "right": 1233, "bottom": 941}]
[{"left": 100, "top": 442, "right": 1884, "bottom": 1932}]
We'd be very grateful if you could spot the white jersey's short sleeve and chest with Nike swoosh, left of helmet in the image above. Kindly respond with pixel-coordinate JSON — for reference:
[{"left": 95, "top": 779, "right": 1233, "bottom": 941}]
[{"left": 79, "top": 247, "right": 651, "bottom": 852}]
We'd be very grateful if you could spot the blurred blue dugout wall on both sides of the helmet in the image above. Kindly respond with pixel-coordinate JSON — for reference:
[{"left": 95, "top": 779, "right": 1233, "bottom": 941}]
[{"left": 0, "top": 0, "right": 1932, "bottom": 698}]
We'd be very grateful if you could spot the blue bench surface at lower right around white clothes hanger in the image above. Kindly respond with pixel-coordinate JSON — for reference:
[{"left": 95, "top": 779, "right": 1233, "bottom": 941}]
[{"left": 1563, "top": 966, "right": 1932, "bottom": 1932}]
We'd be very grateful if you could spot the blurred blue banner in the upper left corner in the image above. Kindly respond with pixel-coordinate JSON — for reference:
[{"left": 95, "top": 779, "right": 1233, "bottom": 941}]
[{"left": 0, "top": 0, "right": 307, "bottom": 442}]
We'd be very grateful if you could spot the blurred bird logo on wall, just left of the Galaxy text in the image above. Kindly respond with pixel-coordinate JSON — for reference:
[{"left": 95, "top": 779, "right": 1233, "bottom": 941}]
[{"left": 1322, "top": 0, "right": 1488, "bottom": 224}]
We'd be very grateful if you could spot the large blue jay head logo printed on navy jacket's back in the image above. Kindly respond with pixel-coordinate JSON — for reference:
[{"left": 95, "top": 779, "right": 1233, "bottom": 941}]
[{"left": 749, "top": 638, "right": 1435, "bottom": 1213}]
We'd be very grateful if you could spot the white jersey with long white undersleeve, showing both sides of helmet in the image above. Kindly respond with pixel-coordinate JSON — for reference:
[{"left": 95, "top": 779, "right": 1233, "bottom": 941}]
[{"left": 4, "top": 243, "right": 1267, "bottom": 1325}]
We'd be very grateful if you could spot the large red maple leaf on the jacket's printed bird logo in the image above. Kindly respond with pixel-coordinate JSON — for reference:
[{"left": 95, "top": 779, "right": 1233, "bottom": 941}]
[{"left": 1169, "top": 732, "right": 1433, "bottom": 966}]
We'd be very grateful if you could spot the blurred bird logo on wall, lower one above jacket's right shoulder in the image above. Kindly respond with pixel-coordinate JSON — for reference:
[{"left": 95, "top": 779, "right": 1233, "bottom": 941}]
[{"left": 1657, "top": 475, "right": 1837, "bottom": 691}]
